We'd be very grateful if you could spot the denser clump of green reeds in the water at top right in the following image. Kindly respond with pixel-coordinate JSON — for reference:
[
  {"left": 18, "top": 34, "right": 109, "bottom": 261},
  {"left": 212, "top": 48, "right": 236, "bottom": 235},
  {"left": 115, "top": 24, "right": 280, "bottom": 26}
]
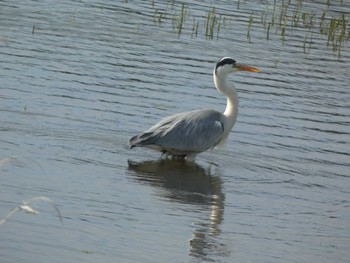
[{"left": 256, "top": 0, "right": 350, "bottom": 55}]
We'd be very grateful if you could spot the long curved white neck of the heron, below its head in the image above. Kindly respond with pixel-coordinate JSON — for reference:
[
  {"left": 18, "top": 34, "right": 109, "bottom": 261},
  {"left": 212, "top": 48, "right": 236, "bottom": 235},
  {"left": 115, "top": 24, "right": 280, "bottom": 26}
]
[{"left": 214, "top": 74, "right": 238, "bottom": 130}]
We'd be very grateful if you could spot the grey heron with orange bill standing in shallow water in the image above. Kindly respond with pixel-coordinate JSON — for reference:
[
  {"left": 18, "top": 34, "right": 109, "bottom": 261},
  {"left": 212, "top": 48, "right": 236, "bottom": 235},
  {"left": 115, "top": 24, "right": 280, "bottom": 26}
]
[{"left": 129, "top": 57, "right": 260, "bottom": 161}]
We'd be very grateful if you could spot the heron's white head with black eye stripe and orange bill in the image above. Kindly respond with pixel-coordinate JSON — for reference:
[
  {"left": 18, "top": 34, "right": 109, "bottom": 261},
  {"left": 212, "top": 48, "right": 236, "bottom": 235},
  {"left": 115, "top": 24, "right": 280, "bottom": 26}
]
[{"left": 214, "top": 57, "right": 260, "bottom": 76}]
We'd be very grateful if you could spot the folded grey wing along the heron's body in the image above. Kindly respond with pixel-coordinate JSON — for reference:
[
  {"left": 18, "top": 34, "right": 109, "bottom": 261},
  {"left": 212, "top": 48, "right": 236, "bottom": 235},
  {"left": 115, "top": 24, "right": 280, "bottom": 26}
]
[{"left": 130, "top": 110, "right": 224, "bottom": 153}]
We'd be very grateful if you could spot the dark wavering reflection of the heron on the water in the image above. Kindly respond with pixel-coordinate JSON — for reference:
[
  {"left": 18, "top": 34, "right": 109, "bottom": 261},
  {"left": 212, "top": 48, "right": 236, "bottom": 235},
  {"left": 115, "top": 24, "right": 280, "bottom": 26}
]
[{"left": 128, "top": 159, "right": 228, "bottom": 260}]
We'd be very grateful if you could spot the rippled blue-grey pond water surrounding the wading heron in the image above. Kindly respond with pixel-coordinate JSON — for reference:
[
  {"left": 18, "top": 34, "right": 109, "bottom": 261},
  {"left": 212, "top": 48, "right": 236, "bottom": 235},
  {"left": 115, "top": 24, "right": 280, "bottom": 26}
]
[{"left": 0, "top": 0, "right": 350, "bottom": 262}]
